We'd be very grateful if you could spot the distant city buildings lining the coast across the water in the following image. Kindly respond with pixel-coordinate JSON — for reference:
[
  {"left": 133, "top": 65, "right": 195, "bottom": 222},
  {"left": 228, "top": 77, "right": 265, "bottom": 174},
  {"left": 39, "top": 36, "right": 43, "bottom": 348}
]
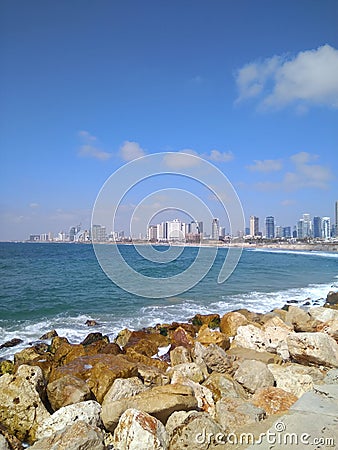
[{"left": 28, "top": 201, "right": 338, "bottom": 243}]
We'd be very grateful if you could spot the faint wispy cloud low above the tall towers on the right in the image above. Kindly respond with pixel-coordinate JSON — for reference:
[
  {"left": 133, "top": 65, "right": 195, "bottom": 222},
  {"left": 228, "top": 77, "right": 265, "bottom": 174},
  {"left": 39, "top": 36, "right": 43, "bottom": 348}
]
[{"left": 255, "top": 152, "right": 334, "bottom": 191}]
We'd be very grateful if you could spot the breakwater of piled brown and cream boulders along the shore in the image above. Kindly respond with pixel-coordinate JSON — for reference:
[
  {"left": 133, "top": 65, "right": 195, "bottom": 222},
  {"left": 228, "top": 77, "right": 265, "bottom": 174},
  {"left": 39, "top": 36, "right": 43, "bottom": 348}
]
[{"left": 0, "top": 293, "right": 338, "bottom": 450}]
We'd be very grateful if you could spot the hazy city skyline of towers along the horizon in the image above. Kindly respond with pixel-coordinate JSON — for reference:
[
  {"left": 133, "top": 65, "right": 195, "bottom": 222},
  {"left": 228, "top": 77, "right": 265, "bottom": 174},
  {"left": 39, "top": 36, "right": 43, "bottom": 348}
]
[{"left": 27, "top": 200, "right": 338, "bottom": 242}]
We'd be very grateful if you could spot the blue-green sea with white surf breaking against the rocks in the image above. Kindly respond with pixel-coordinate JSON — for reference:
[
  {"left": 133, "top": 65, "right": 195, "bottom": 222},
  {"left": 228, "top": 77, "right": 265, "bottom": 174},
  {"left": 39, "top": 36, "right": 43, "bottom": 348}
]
[{"left": 0, "top": 242, "right": 338, "bottom": 359}]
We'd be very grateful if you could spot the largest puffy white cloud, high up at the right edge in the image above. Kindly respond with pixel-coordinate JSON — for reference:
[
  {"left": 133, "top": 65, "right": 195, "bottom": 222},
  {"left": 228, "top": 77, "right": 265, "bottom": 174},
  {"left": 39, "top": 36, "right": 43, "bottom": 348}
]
[{"left": 236, "top": 44, "right": 338, "bottom": 112}]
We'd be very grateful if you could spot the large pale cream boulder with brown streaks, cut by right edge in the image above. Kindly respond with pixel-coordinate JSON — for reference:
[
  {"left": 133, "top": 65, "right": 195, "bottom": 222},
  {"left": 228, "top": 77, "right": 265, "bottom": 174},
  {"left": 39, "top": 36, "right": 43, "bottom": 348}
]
[{"left": 287, "top": 332, "right": 338, "bottom": 367}]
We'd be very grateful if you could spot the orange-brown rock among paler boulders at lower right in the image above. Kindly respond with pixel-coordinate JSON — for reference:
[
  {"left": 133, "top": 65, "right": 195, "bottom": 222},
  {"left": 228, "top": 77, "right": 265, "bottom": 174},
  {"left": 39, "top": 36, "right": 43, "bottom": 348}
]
[{"left": 251, "top": 386, "right": 298, "bottom": 415}]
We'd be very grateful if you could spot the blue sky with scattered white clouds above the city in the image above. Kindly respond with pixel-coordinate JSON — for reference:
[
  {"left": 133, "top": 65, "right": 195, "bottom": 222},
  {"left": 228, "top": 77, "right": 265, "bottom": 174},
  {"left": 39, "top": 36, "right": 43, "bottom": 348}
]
[{"left": 0, "top": 0, "right": 338, "bottom": 240}]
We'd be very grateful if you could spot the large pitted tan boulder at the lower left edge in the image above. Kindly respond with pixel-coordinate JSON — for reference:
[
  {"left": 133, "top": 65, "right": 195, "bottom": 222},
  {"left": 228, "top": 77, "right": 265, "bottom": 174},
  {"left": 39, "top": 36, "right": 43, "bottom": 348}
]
[{"left": 0, "top": 365, "right": 49, "bottom": 443}]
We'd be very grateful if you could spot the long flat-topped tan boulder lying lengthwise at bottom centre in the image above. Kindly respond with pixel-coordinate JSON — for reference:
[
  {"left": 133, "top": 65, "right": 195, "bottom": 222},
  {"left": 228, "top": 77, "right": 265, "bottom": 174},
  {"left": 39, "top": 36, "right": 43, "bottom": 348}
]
[{"left": 102, "top": 384, "right": 198, "bottom": 431}]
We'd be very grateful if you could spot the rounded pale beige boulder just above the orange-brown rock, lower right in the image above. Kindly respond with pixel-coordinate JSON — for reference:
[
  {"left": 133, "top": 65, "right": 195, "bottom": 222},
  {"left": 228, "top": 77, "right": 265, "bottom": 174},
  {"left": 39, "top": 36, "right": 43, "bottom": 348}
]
[{"left": 234, "top": 359, "right": 275, "bottom": 394}]
